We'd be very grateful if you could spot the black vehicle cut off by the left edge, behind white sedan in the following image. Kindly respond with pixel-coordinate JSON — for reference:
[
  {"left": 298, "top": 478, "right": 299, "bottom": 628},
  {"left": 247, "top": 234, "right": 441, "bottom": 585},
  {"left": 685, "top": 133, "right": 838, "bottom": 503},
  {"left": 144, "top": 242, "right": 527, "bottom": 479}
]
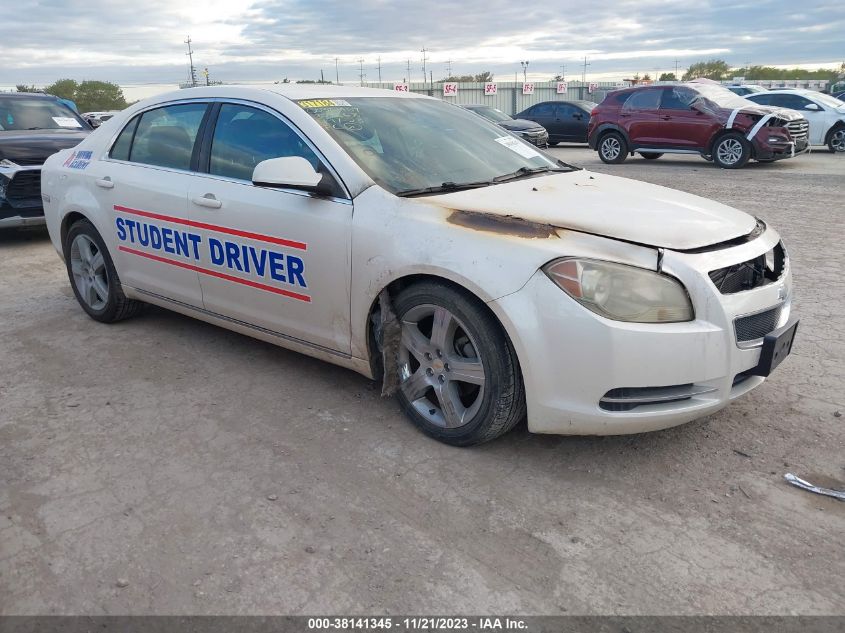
[{"left": 0, "top": 92, "right": 91, "bottom": 228}]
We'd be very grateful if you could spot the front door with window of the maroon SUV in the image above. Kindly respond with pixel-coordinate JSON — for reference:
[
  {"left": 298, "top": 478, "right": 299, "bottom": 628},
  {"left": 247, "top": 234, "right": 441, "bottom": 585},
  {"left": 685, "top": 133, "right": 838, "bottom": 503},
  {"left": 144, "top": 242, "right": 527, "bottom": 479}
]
[{"left": 655, "top": 86, "right": 720, "bottom": 150}]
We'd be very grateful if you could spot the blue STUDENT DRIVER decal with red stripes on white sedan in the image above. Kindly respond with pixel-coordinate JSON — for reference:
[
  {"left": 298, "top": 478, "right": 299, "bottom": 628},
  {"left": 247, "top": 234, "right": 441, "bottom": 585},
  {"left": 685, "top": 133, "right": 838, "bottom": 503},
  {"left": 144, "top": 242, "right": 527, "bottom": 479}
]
[{"left": 114, "top": 205, "right": 311, "bottom": 303}]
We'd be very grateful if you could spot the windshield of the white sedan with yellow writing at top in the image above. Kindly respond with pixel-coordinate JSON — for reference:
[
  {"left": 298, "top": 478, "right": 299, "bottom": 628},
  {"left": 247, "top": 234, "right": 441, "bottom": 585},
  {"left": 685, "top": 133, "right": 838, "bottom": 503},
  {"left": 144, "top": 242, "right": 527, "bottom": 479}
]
[{"left": 297, "top": 97, "right": 573, "bottom": 195}]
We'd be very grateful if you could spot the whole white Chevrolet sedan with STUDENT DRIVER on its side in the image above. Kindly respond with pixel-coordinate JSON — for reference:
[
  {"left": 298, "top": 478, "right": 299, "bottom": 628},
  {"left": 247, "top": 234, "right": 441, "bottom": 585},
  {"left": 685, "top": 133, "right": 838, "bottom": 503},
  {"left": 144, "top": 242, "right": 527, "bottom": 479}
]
[{"left": 43, "top": 85, "right": 797, "bottom": 445}]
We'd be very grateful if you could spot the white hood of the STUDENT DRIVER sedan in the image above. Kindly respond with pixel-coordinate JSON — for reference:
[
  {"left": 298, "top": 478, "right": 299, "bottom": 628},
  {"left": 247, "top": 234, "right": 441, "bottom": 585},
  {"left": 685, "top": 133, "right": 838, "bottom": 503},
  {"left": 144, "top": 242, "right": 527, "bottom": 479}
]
[{"left": 425, "top": 171, "right": 757, "bottom": 250}]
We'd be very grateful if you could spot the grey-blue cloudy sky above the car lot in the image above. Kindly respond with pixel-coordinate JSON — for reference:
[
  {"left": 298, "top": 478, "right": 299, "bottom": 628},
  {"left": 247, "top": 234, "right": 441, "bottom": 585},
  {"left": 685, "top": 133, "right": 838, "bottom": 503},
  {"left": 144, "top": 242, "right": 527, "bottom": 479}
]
[{"left": 0, "top": 0, "right": 845, "bottom": 96}]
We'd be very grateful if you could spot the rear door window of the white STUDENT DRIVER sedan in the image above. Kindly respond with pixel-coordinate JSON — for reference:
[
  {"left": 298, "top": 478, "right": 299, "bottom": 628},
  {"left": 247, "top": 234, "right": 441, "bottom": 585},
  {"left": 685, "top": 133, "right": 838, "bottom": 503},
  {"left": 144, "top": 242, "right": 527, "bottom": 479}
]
[{"left": 125, "top": 103, "right": 208, "bottom": 170}]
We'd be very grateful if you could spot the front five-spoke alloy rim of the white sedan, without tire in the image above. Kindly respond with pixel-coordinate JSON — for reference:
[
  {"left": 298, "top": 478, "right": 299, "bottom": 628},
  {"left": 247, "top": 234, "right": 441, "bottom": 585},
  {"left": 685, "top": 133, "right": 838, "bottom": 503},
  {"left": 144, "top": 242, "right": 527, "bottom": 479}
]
[{"left": 399, "top": 304, "right": 485, "bottom": 429}]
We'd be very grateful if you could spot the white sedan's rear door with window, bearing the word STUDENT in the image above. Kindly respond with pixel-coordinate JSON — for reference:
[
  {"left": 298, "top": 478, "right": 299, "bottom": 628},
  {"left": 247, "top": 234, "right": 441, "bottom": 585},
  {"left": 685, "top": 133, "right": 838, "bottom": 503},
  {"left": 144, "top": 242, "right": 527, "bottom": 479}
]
[{"left": 94, "top": 102, "right": 209, "bottom": 307}]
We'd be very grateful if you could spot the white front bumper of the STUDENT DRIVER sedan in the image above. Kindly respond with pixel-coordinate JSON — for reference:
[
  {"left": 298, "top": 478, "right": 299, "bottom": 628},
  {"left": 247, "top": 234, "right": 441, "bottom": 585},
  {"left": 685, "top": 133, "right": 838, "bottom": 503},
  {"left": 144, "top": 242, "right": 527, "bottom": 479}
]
[{"left": 492, "top": 230, "right": 791, "bottom": 435}]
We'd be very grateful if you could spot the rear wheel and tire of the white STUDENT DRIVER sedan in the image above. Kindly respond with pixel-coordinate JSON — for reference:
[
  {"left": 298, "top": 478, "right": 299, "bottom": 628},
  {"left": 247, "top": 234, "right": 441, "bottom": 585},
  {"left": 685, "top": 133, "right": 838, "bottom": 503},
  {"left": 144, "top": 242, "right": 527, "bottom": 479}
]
[{"left": 64, "top": 220, "right": 144, "bottom": 323}]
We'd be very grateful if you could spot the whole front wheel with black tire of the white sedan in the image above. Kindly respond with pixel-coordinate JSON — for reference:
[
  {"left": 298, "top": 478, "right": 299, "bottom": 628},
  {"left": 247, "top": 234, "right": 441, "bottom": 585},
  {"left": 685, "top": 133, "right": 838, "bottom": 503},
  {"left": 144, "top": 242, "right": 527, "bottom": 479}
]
[{"left": 394, "top": 282, "right": 526, "bottom": 446}]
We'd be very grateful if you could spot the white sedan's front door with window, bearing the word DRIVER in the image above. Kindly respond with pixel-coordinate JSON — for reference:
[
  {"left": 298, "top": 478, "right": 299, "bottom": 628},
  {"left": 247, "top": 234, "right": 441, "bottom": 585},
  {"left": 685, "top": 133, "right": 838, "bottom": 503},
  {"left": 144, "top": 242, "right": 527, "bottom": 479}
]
[{"left": 188, "top": 102, "right": 352, "bottom": 354}]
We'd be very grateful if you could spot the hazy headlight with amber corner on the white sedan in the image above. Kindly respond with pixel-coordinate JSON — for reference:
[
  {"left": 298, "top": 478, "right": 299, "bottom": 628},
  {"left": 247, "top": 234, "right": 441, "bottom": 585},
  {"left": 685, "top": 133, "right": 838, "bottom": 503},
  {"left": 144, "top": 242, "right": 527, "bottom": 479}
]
[{"left": 543, "top": 259, "right": 694, "bottom": 323}]
